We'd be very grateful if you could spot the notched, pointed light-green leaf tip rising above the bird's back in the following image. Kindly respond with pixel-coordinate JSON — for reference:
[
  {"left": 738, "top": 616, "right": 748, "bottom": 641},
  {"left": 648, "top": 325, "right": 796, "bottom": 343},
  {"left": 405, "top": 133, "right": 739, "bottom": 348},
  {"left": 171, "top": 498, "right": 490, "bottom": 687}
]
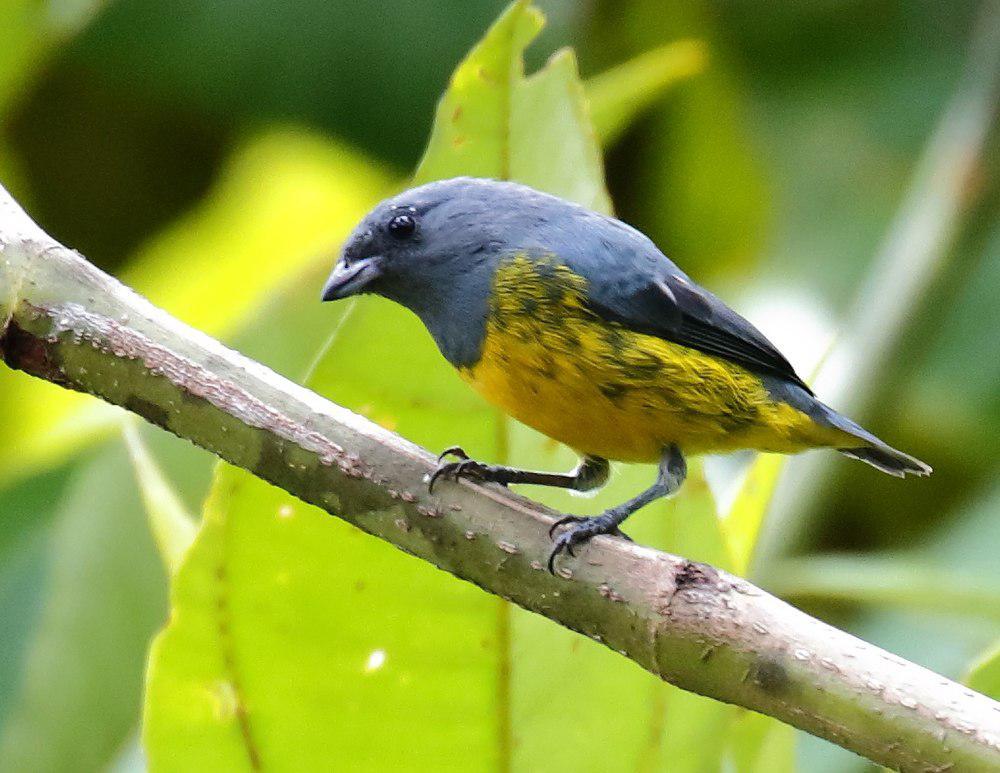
[{"left": 414, "top": 1, "right": 611, "bottom": 212}]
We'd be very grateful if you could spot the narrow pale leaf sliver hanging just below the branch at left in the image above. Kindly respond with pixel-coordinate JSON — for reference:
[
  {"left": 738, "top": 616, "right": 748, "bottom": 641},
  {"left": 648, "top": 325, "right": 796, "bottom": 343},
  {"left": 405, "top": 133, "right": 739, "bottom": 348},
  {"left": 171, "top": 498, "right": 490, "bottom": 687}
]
[{"left": 122, "top": 419, "right": 198, "bottom": 575}]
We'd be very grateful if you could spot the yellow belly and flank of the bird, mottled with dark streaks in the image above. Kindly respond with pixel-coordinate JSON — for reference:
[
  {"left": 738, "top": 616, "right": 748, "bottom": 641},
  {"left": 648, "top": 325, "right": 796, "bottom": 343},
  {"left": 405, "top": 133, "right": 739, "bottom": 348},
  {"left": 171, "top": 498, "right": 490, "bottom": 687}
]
[{"left": 460, "top": 256, "right": 843, "bottom": 462}]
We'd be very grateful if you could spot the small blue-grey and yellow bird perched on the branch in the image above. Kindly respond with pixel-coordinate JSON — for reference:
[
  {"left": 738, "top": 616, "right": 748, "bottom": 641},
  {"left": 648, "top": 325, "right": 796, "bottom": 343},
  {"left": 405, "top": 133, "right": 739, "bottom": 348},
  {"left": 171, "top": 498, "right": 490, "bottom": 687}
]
[{"left": 322, "top": 177, "right": 931, "bottom": 571}]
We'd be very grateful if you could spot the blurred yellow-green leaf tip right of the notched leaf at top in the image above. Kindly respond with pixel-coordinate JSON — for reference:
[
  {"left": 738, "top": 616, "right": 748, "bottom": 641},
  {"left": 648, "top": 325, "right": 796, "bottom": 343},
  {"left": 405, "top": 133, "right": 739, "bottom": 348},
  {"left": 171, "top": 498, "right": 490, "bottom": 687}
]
[{"left": 587, "top": 40, "right": 707, "bottom": 146}]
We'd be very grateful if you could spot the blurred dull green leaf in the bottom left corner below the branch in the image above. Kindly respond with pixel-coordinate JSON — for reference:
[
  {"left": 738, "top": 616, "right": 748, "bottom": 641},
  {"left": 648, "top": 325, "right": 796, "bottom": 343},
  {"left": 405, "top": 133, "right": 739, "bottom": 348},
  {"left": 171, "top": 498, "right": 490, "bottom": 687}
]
[{"left": 0, "top": 444, "right": 166, "bottom": 771}]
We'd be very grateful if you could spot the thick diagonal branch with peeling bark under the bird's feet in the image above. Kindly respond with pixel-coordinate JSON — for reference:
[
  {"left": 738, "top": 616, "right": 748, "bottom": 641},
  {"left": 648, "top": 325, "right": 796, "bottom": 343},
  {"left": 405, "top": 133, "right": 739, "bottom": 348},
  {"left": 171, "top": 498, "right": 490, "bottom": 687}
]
[{"left": 0, "top": 188, "right": 1000, "bottom": 771}]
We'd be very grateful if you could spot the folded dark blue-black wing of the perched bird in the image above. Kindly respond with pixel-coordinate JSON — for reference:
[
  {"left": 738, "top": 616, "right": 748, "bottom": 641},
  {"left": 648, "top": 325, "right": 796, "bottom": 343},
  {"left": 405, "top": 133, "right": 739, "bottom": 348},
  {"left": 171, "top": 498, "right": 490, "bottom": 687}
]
[{"left": 588, "top": 252, "right": 812, "bottom": 394}]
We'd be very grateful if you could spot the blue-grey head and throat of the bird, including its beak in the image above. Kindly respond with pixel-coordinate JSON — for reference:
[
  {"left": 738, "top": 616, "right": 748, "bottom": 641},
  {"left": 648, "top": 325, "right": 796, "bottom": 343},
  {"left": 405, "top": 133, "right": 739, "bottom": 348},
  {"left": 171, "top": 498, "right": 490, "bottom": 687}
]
[{"left": 323, "top": 177, "right": 586, "bottom": 365}]
